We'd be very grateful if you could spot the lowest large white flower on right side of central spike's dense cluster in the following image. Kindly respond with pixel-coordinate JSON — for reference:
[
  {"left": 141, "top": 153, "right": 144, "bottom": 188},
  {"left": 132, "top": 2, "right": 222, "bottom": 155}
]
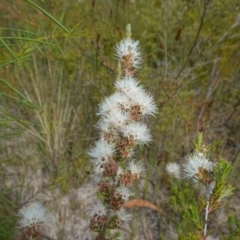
[{"left": 122, "top": 122, "right": 152, "bottom": 145}]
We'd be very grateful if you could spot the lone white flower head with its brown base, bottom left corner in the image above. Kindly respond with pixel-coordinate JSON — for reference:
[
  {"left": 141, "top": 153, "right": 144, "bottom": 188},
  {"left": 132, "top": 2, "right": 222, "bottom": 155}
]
[{"left": 18, "top": 202, "right": 53, "bottom": 239}]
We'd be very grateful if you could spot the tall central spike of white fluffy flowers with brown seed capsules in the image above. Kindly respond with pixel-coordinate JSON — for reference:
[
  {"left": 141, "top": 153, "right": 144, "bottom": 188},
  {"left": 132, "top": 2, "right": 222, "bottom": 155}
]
[{"left": 88, "top": 26, "right": 157, "bottom": 239}]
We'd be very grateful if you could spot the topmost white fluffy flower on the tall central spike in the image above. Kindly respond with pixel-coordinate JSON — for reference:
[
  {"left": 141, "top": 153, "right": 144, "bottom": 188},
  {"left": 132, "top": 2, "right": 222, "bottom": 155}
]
[{"left": 116, "top": 38, "right": 142, "bottom": 68}]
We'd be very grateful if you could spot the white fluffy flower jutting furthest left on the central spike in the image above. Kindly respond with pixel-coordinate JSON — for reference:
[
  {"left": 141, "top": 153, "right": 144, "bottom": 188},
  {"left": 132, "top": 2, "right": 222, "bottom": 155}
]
[{"left": 88, "top": 139, "right": 114, "bottom": 166}]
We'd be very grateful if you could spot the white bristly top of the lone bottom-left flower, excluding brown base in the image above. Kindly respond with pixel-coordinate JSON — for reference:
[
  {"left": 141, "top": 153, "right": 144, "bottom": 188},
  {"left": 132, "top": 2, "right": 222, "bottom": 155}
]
[{"left": 18, "top": 202, "right": 53, "bottom": 228}]
